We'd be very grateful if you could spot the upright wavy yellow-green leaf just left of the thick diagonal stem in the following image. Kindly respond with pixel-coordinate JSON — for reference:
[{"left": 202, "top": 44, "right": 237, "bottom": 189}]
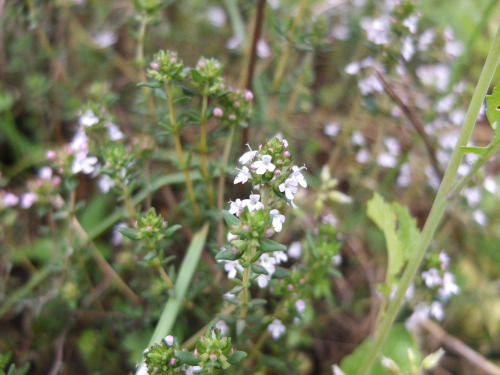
[{"left": 367, "top": 193, "right": 404, "bottom": 282}]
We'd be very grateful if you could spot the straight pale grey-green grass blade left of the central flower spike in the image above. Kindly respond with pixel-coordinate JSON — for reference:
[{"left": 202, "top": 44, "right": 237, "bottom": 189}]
[{"left": 149, "top": 223, "right": 209, "bottom": 346}]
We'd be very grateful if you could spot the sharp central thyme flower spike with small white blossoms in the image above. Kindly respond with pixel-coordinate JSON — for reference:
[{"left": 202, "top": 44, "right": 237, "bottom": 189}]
[{"left": 216, "top": 138, "right": 307, "bottom": 294}]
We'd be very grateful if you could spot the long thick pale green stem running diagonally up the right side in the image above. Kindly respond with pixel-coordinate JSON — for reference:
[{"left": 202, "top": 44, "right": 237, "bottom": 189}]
[{"left": 357, "top": 28, "right": 500, "bottom": 375}]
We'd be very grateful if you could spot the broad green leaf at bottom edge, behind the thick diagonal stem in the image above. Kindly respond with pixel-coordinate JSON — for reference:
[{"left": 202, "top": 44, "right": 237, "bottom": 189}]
[{"left": 340, "top": 324, "right": 421, "bottom": 375}]
